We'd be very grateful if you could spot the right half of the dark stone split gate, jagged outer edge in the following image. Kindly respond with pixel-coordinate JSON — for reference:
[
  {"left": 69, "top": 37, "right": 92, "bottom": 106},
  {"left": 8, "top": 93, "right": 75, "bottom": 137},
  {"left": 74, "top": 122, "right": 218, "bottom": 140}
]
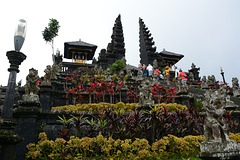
[{"left": 139, "top": 18, "right": 162, "bottom": 66}]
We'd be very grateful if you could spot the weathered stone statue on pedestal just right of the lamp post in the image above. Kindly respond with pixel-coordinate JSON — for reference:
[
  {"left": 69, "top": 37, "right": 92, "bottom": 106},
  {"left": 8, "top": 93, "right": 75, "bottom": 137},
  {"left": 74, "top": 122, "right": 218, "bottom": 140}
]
[{"left": 22, "top": 68, "right": 40, "bottom": 102}]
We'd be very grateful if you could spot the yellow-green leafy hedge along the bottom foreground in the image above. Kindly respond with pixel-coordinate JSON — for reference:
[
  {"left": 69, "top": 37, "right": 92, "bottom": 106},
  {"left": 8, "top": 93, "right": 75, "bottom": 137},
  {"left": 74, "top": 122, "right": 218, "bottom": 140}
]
[{"left": 26, "top": 133, "right": 208, "bottom": 160}]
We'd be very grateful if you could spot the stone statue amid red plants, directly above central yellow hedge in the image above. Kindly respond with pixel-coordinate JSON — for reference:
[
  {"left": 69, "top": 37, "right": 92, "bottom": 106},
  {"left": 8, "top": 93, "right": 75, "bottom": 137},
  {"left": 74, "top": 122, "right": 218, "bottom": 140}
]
[{"left": 138, "top": 78, "right": 154, "bottom": 107}]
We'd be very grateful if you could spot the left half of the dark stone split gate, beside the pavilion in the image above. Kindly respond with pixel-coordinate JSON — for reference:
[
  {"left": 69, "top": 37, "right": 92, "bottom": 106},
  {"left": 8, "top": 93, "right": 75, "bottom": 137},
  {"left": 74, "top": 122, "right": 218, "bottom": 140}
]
[{"left": 97, "top": 14, "right": 125, "bottom": 69}]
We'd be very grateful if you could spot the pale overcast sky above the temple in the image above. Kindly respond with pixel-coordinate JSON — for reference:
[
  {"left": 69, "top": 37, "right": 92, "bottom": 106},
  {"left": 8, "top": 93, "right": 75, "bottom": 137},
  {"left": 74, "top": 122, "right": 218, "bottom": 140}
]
[{"left": 0, "top": 0, "right": 240, "bottom": 85}]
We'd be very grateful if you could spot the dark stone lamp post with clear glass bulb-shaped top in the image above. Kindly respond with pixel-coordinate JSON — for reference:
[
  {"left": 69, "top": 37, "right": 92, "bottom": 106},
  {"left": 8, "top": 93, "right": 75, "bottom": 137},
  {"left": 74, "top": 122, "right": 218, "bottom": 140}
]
[{"left": 1, "top": 19, "right": 27, "bottom": 119}]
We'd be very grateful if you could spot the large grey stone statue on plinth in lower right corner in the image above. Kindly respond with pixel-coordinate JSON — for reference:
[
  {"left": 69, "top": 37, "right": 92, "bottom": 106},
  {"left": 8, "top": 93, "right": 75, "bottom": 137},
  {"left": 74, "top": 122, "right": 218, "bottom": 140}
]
[{"left": 199, "top": 89, "right": 240, "bottom": 159}]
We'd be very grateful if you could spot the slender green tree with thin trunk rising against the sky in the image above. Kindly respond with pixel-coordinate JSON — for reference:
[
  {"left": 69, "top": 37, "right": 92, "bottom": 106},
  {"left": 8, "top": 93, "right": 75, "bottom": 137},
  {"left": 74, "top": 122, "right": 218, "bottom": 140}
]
[{"left": 42, "top": 18, "right": 60, "bottom": 54}]
